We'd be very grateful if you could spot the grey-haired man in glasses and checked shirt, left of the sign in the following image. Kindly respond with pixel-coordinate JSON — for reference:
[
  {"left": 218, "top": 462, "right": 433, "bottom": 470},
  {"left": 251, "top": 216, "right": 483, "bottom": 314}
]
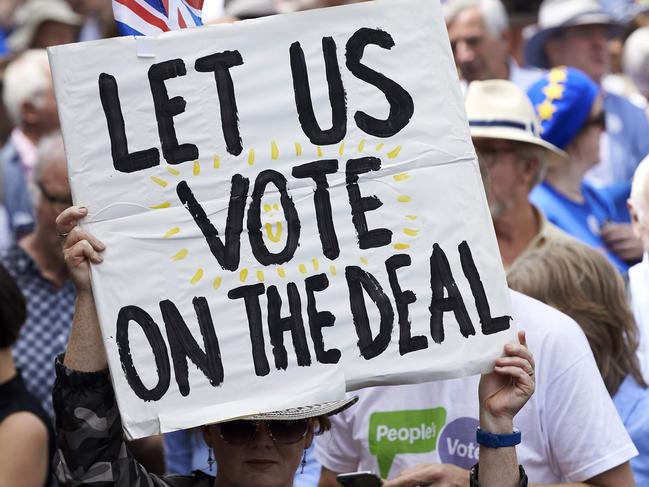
[{"left": 1, "top": 134, "right": 75, "bottom": 416}]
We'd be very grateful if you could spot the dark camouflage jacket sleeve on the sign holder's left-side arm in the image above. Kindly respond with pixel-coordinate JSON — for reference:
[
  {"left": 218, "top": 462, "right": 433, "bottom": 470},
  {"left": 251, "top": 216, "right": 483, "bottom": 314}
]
[{"left": 52, "top": 357, "right": 210, "bottom": 487}]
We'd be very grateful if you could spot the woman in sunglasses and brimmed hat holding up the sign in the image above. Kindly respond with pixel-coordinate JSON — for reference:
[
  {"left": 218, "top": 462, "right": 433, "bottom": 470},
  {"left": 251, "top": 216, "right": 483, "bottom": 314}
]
[{"left": 53, "top": 207, "right": 534, "bottom": 487}]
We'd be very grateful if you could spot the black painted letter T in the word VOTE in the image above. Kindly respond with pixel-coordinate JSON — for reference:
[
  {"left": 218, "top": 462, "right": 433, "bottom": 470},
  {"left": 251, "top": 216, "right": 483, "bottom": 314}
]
[{"left": 293, "top": 159, "right": 340, "bottom": 260}]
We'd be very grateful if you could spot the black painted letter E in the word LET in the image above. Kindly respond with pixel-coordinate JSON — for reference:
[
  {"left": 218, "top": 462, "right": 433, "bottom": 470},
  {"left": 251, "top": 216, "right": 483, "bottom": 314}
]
[{"left": 149, "top": 59, "right": 198, "bottom": 164}]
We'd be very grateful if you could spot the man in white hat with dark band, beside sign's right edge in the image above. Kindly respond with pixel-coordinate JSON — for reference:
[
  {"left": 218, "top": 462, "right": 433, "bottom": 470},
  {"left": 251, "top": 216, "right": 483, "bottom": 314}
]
[{"left": 466, "top": 80, "right": 570, "bottom": 267}]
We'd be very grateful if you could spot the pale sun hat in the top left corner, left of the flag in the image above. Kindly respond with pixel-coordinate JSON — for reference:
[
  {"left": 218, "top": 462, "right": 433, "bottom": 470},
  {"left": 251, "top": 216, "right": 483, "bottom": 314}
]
[{"left": 7, "top": 0, "right": 83, "bottom": 52}]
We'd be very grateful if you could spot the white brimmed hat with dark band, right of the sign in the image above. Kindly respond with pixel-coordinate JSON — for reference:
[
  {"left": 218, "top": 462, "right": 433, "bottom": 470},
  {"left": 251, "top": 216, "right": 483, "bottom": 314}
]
[{"left": 465, "top": 79, "right": 568, "bottom": 164}]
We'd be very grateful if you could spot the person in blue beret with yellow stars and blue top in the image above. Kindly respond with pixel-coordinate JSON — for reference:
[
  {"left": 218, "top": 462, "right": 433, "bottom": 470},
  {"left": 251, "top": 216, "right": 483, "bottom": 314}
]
[{"left": 527, "top": 66, "right": 642, "bottom": 272}]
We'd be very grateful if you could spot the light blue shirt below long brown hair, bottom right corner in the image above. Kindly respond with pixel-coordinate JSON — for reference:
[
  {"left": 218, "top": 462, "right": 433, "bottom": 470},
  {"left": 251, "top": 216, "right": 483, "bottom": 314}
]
[{"left": 612, "top": 376, "right": 649, "bottom": 486}]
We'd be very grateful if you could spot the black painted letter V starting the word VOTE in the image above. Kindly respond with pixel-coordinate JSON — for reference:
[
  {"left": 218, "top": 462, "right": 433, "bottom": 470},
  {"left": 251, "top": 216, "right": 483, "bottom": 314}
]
[{"left": 176, "top": 174, "right": 249, "bottom": 271}]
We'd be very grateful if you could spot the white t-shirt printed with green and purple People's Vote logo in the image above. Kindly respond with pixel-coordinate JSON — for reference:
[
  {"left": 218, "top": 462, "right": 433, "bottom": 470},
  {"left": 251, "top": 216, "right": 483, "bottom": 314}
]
[{"left": 316, "top": 291, "right": 637, "bottom": 483}]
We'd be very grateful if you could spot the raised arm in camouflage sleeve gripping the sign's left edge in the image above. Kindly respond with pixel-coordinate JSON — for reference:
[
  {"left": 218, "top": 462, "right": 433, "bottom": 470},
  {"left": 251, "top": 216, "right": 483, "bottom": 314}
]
[{"left": 53, "top": 207, "right": 168, "bottom": 487}]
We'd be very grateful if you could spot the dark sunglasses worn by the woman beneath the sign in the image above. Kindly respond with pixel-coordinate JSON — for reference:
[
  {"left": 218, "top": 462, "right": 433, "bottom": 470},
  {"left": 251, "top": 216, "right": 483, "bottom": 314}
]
[{"left": 217, "top": 419, "right": 309, "bottom": 445}]
